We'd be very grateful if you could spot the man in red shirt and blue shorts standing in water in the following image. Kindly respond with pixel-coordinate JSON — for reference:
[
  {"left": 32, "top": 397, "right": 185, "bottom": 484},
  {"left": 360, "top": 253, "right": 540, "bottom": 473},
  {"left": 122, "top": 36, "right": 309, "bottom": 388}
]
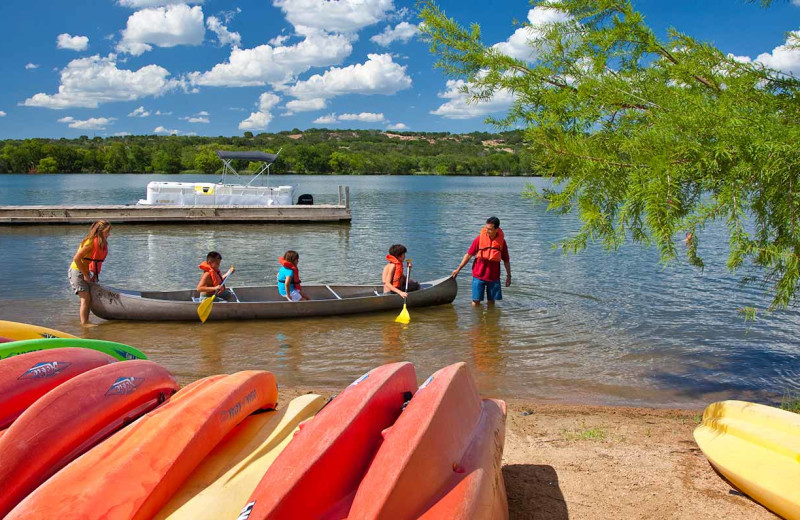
[{"left": 453, "top": 217, "right": 511, "bottom": 306}]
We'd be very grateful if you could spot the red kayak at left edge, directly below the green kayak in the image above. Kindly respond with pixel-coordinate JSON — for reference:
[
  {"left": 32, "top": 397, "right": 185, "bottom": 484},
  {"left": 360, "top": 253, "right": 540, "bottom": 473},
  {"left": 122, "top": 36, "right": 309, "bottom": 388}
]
[{"left": 0, "top": 348, "right": 116, "bottom": 430}]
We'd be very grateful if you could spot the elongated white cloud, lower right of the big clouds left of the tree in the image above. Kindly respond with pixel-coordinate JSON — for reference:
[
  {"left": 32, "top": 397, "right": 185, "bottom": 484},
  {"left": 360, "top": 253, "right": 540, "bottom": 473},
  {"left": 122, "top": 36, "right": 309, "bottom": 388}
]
[{"left": 286, "top": 54, "right": 411, "bottom": 99}]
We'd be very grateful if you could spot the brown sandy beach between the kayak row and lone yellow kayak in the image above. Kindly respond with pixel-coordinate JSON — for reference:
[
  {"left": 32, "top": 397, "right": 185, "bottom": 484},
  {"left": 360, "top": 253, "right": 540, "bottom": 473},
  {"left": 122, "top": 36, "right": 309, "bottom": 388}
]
[{"left": 280, "top": 387, "right": 778, "bottom": 520}]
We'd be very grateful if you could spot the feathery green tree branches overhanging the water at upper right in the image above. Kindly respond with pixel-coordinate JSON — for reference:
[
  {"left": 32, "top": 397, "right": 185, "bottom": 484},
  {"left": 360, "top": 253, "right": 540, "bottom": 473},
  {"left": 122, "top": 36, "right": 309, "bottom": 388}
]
[{"left": 420, "top": 0, "right": 800, "bottom": 312}]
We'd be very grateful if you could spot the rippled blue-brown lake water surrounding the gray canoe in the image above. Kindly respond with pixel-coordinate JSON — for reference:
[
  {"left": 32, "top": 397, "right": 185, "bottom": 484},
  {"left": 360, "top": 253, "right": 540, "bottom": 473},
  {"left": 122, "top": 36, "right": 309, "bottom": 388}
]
[{"left": 0, "top": 175, "right": 800, "bottom": 406}]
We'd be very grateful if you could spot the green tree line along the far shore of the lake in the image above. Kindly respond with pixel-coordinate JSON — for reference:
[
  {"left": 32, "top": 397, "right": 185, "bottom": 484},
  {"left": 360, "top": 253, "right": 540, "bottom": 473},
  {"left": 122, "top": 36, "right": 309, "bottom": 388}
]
[{"left": 0, "top": 128, "right": 538, "bottom": 175}]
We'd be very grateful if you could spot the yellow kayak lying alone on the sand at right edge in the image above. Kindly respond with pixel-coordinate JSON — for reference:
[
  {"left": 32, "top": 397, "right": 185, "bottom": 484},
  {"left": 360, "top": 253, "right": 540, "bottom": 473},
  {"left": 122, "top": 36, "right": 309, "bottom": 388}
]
[{"left": 694, "top": 401, "right": 800, "bottom": 519}]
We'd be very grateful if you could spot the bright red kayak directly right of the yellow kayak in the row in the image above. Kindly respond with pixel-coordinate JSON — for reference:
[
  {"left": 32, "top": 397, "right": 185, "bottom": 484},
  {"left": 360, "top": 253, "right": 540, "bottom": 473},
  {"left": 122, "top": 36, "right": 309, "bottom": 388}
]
[{"left": 239, "top": 363, "right": 417, "bottom": 520}]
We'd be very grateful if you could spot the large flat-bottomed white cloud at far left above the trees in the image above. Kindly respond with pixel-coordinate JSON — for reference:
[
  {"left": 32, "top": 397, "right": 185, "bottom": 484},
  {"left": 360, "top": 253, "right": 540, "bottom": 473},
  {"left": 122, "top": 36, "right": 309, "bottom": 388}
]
[{"left": 22, "top": 54, "right": 183, "bottom": 109}]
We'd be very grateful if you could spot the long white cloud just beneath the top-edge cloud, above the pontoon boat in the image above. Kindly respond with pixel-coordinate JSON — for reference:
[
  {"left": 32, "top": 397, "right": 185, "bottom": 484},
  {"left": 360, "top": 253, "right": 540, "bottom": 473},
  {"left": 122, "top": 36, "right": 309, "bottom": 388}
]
[{"left": 189, "top": 31, "right": 353, "bottom": 87}]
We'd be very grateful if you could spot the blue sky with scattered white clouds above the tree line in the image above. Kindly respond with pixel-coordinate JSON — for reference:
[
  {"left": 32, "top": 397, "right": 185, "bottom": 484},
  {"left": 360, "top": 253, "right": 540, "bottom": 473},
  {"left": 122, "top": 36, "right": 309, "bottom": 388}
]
[{"left": 0, "top": 0, "right": 800, "bottom": 139}]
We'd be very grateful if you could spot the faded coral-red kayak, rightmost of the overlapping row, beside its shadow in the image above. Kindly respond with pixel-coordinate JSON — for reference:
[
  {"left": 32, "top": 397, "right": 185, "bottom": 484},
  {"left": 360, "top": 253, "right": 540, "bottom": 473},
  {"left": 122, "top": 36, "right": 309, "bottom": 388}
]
[{"left": 347, "top": 363, "right": 508, "bottom": 520}]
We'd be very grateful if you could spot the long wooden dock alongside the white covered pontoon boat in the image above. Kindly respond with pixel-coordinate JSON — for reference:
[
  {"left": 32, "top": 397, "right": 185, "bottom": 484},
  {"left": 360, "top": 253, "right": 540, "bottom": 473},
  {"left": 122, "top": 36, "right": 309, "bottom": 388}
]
[{"left": 0, "top": 186, "right": 352, "bottom": 225}]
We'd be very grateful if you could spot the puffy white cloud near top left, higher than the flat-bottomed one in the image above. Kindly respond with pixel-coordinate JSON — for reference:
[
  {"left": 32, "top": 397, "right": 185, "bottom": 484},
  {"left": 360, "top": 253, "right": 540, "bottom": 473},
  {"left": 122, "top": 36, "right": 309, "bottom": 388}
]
[{"left": 117, "top": 4, "right": 206, "bottom": 56}]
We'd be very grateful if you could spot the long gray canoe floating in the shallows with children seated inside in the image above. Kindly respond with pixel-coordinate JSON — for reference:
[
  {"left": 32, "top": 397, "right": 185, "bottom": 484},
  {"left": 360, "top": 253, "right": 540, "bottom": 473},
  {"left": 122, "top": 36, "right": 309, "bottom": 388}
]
[{"left": 91, "top": 276, "right": 458, "bottom": 321}]
